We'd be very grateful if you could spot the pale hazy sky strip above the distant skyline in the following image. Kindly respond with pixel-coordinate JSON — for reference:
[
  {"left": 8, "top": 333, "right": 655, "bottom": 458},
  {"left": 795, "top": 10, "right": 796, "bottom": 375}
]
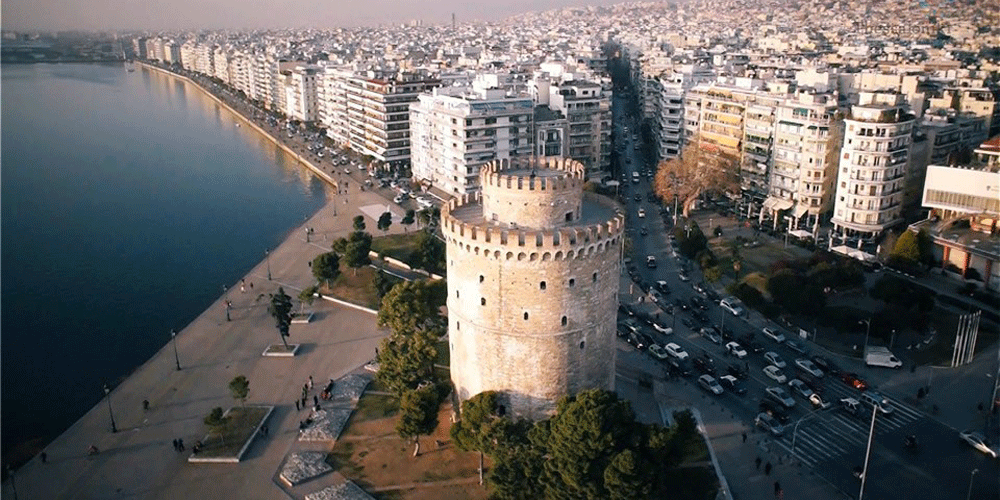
[{"left": 2, "top": 0, "right": 622, "bottom": 30}]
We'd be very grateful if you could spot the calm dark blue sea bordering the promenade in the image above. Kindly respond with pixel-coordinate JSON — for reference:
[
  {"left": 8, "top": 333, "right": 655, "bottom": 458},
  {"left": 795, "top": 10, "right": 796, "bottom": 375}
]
[{"left": 0, "top": 65, "right": 326, "bottom": 455}]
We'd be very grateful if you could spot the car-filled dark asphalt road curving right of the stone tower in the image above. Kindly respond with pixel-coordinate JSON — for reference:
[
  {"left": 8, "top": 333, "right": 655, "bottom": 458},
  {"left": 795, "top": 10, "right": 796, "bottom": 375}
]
[{"left": 616, "top": 93, "right": 1000, "bottom": 499}]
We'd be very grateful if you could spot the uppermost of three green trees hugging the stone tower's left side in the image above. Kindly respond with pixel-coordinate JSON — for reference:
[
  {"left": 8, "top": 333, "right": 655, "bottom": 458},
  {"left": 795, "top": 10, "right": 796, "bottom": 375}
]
[{"left": 378, "top": 280, "right": 448, "bottom": 339}]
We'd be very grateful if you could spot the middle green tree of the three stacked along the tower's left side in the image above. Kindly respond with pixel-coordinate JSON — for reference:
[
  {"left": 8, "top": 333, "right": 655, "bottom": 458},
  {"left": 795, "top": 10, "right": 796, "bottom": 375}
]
[{"left": 375, "top": 334, "right": 437, "bottom": 397}]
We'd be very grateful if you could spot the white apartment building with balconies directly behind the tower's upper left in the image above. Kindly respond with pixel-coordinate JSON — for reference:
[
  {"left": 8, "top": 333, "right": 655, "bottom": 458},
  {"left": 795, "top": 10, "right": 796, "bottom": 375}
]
[{"left": 410, "top": 81, "right": 534, "bottom": 195}]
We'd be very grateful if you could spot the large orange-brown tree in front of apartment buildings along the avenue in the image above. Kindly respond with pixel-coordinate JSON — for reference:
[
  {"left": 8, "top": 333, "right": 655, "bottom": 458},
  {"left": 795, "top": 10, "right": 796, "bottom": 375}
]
[{"left": 653, "top": 136, "right": 739, "bottom": 217}]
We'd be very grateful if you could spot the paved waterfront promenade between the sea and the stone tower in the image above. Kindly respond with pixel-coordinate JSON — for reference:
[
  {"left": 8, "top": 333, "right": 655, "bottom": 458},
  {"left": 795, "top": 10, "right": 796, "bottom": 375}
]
[{"left": 3, "top": 67, "right": 402, "bottom": 499}]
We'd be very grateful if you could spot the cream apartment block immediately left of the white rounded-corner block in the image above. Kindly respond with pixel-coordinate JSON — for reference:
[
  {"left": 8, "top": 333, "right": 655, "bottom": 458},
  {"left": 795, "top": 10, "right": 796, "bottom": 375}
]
[{"left": 762, "top": 92, "right": 843, "bottom": 227}]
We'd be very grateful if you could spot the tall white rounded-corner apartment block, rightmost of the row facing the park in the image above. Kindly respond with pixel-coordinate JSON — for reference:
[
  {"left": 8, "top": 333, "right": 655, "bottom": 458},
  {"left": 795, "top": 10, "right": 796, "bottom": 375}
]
[{"left": 833, "top": 91, "right": 914, "bottom": 235}]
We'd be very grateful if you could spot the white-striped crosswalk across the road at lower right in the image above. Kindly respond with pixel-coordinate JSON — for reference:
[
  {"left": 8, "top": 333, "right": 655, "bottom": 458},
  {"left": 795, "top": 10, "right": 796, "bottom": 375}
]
[{"left": 777, "top": 380, "right": 925, "bottom": 467}]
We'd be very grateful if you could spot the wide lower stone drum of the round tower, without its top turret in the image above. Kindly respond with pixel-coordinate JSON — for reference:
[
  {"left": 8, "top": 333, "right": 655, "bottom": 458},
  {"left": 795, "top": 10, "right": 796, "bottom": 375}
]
[{"left": 442, "top": 162, "right": 624, "bottom": 419}]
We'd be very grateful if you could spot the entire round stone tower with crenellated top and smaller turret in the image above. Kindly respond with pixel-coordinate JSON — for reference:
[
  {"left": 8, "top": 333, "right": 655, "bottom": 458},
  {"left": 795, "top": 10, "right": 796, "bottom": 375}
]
[{"left": 441, "top": 159, "right": 625, "bottom": 419}]
